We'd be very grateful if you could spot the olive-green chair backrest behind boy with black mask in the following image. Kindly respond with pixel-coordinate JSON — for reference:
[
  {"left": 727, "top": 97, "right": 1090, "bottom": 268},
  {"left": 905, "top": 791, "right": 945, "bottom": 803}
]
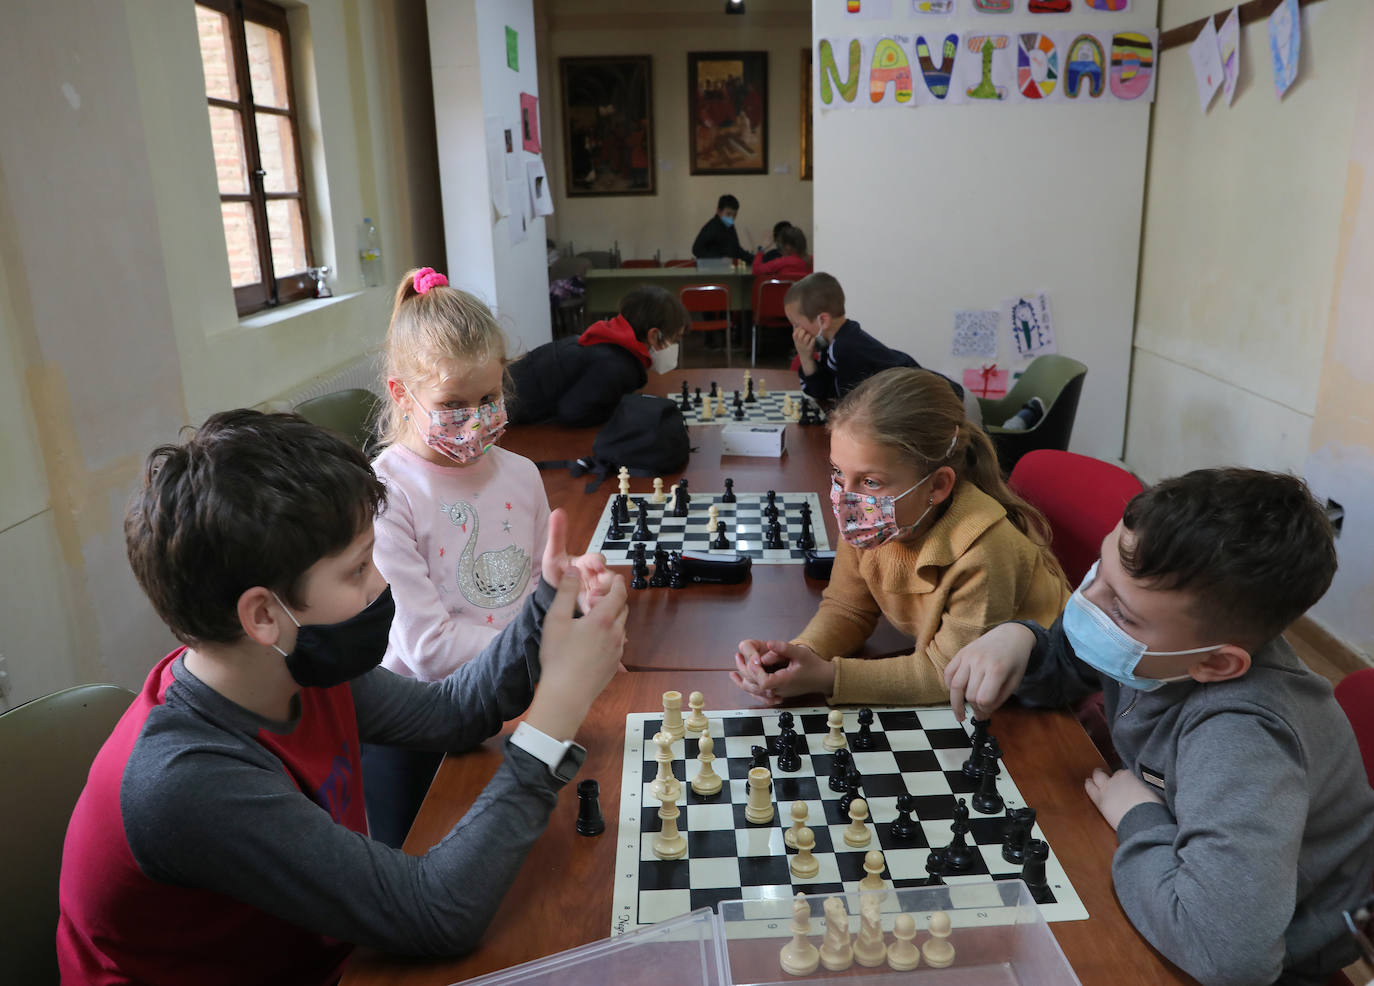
[{"left": 0, "top": 685, "right": 133, "bottom": 983}]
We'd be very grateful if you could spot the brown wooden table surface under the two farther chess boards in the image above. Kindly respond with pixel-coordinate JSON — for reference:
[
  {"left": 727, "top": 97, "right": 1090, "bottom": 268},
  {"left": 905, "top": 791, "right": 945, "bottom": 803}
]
[{"left": 502, "top": 369, "right": 911, "bottom": 670}]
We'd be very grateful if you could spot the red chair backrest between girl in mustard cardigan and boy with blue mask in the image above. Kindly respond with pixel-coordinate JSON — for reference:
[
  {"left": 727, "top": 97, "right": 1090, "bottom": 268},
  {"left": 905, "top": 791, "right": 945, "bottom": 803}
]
[{"left": 1009, "top": 449, "right": 1145, "bottom": 585}]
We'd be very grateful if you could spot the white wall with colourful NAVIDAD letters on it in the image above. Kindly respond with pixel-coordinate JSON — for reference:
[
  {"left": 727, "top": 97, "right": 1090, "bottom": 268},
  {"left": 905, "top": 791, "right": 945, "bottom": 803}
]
[{"left": 813, "top": 0, "right": 1156, "bottom": 459}]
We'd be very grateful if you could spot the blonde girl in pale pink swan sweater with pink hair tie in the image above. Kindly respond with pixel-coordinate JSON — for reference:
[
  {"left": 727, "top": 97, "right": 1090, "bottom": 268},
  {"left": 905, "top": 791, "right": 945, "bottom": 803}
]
[{"left": 363, "top": 268, "right": 548, "bottom": 846}]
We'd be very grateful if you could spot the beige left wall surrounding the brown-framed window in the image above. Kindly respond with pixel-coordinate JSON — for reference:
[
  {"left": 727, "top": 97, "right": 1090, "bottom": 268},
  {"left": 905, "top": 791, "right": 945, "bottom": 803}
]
[{"left": 0, "top": 0, "right": 441, "bottom": 706}]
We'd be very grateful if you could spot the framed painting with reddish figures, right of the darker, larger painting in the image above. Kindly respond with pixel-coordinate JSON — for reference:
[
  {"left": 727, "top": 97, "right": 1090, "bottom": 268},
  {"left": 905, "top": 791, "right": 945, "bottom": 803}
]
[{"left": 687, "top": 51, "right": 768, "bottom": 174}]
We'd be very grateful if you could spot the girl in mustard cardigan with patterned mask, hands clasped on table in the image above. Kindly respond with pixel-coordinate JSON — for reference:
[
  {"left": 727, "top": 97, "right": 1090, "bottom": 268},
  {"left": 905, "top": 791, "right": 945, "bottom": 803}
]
[{"left": 731, "top": 368, "right": 1069, "bottom": 704}]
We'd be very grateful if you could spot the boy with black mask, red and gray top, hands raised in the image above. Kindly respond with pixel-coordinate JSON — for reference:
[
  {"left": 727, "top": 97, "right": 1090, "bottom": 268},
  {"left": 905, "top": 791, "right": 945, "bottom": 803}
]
[{"left": 58, "top": 411, "right": 625, "bottom": 983}]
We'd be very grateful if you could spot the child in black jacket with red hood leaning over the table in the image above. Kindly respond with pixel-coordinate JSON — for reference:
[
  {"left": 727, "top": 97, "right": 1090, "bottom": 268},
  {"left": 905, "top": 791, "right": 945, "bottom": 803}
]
[{"left": 510, "top": 284, "right": 687, "bottom": 428}]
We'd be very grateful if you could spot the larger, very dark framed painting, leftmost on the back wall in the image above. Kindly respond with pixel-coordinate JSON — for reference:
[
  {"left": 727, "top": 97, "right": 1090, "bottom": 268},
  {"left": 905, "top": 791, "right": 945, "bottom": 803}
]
[{"left": 558, "top": 55, "right": 658, "bottom": 198}]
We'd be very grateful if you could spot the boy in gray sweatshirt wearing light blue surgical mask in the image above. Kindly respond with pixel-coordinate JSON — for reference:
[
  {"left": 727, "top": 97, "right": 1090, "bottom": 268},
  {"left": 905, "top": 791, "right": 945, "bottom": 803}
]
[{"left": 945, "top": 470, "right": 1374, "bottom": 986}]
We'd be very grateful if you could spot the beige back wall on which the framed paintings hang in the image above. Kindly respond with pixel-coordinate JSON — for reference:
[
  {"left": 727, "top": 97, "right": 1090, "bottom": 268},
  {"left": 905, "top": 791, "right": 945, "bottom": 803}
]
[{"left": 536, "top": 0, "right": 812, "bottom": 260}]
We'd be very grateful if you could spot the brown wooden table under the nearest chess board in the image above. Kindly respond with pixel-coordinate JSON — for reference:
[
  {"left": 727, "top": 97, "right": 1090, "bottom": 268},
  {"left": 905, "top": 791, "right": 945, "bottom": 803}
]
[{"left": 342, "top": 672, "right": 1193, "bottom": 986}]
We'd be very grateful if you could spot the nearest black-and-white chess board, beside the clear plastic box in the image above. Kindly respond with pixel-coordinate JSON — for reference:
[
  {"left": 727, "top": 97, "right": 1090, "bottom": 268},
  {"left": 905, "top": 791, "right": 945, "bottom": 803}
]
[{"left": 611, "top": 707, "right": 1088, "bottom": 934}]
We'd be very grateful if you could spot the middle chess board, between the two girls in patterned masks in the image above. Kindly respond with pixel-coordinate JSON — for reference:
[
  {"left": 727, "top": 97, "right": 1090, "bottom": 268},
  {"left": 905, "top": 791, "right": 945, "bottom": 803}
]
[{"left": 587, "top": 490, "right": 830, "bottom": 564}]
